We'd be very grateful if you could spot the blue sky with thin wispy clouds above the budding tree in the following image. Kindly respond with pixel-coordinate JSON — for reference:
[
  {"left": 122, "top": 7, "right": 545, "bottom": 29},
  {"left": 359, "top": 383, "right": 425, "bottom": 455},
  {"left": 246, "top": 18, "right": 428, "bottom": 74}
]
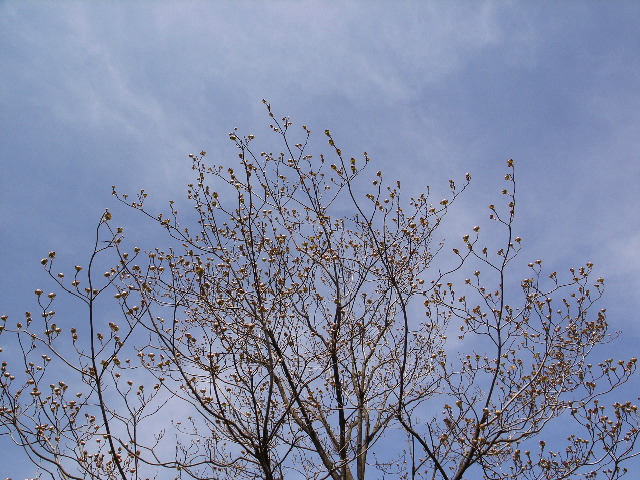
[{"left": 0, "top": 0, "right": 640, "bottom": 479}]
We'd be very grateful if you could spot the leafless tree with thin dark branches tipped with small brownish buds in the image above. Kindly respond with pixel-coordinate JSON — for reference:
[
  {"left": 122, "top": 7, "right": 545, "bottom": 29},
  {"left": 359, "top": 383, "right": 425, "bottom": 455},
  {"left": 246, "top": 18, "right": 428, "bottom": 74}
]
[{"left": 0, "top": 102, "right": 640, "bottom": 480}]
